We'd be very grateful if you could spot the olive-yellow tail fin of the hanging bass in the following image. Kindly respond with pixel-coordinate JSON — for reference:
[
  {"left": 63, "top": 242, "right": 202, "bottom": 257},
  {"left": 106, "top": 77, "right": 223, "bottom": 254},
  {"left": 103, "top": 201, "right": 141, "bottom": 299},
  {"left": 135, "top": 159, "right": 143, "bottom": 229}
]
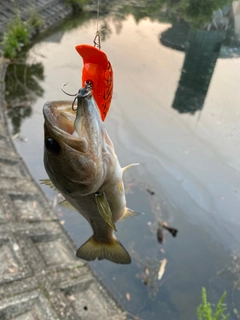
[{"left": 76, "top": 236, "right": 131, "bottom": 264}]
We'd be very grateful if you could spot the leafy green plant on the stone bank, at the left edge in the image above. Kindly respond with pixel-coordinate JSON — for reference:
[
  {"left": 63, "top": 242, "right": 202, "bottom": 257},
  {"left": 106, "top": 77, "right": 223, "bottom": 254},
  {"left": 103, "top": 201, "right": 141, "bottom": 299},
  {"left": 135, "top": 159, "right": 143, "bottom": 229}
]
[{"left": 2, "top": 11, "right": 31, "bottom": 59}]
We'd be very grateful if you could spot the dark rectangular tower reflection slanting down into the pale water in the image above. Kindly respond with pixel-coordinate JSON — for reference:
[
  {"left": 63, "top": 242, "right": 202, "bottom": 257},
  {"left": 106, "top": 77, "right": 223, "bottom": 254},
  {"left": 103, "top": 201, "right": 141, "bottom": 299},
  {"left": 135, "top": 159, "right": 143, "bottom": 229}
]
[{"left": 172, "top": 30, "right": 225, "bottom": 113}]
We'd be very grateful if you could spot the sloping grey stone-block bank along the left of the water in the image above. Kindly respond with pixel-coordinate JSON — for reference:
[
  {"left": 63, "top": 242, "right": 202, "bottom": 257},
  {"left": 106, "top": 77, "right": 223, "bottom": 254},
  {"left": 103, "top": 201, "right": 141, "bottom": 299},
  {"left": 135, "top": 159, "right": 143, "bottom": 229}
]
[{"left": 0, "top": 1, "right": 126, "bottom": 320}]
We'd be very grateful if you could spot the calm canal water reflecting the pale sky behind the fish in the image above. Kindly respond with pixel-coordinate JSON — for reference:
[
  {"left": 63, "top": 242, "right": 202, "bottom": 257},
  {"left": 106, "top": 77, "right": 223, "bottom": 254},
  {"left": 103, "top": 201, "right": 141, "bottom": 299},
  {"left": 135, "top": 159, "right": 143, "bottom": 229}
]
[{"left": 6, "top": 5, "right": 240, "bottom": 320}]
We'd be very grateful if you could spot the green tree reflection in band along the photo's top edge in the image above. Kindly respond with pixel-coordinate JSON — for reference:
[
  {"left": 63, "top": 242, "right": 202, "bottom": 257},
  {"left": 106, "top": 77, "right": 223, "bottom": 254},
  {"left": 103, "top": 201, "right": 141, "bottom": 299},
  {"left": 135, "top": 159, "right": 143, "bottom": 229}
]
[{"left": 90, "top": 0, "right": 232, "bottom": 29}]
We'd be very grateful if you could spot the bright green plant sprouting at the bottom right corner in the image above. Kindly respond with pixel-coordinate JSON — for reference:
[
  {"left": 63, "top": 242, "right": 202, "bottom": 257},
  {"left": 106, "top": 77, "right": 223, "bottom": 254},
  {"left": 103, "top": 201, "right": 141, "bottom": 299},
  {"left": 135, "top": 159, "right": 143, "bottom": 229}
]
[{"left": 197, "top": 288, "right": 229, "bottom": 320}]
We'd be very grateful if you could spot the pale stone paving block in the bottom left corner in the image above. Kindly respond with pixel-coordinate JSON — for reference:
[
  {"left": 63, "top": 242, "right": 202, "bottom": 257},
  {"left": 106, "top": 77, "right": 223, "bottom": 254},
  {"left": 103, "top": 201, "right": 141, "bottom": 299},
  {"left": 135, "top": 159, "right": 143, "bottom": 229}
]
[{"left": 0, "top": 290, "right": 59, "bottom": 320}]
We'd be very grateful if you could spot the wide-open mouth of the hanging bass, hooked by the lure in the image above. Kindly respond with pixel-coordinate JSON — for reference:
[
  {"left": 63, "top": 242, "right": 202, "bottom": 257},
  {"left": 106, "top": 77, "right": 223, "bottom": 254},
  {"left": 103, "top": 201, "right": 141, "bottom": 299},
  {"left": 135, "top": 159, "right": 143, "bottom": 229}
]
[{"left": 43, "top": 86, "right": 105, "bottom": 155}]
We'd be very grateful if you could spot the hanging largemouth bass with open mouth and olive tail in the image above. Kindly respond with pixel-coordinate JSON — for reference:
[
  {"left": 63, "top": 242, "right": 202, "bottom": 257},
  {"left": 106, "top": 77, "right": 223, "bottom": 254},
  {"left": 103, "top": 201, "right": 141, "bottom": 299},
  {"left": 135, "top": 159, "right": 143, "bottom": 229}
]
[{"left": 42, "top": 86, "right": 137, "bottom": 264}]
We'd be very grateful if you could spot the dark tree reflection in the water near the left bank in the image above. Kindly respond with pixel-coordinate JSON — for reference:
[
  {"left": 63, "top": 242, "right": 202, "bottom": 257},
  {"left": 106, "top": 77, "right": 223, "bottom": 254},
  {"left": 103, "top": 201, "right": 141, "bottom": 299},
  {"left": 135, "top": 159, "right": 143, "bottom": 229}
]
[{"left": 5, "top": 53, "right": 44, "bottom": 134}]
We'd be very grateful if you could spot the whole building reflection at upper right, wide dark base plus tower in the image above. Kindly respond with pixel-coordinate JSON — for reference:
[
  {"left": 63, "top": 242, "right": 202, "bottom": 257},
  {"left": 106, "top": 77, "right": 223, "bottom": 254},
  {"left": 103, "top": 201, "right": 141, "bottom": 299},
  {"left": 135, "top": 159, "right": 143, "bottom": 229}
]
[{"left": 160, "top": 0, "right": 240, "bottom": 114}]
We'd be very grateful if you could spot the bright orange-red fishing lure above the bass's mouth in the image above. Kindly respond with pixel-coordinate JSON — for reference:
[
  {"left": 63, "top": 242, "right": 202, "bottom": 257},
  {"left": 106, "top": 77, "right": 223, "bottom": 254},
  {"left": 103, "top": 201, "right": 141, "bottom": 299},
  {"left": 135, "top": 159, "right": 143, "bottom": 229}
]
[{"left": 75, "top": 44, "right": 113, "bottom": 121}]
